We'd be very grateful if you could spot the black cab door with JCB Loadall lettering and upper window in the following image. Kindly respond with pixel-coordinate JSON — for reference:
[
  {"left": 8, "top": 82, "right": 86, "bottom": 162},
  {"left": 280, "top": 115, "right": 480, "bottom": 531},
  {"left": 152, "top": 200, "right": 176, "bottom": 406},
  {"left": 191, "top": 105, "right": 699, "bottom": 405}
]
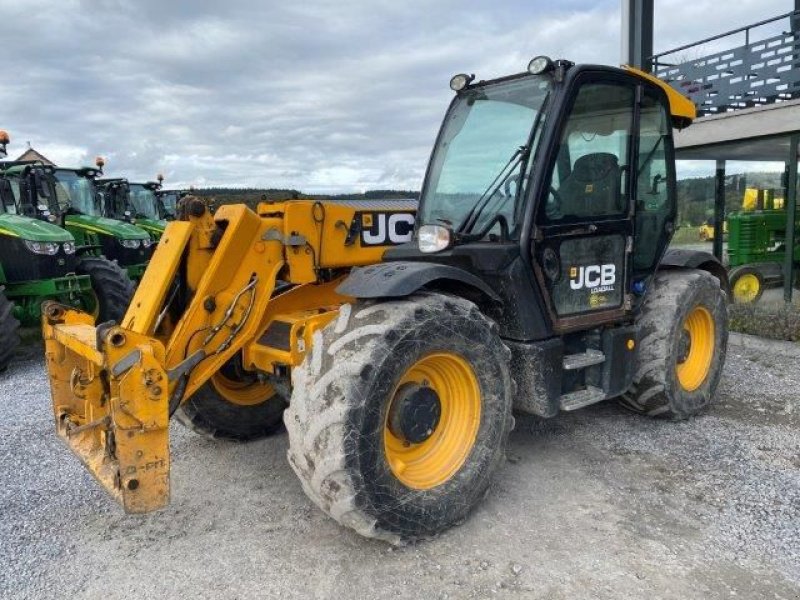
[{"left": 533, "top": 72, "right": 639, "bottom": 332}]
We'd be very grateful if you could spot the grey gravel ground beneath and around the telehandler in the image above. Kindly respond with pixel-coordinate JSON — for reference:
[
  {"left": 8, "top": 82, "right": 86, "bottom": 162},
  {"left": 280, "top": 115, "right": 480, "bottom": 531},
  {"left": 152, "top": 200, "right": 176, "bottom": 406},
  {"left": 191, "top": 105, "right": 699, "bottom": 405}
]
[{"left": 0, "top": 336, "right": 800, "bottom": 600}]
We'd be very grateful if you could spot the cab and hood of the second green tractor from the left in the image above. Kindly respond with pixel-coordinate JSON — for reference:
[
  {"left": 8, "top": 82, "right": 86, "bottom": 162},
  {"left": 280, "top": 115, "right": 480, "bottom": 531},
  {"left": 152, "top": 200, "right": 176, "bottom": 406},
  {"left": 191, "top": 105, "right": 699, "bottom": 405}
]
[{"left": 44, "top": 159, "right": 154, "bottom": 282}]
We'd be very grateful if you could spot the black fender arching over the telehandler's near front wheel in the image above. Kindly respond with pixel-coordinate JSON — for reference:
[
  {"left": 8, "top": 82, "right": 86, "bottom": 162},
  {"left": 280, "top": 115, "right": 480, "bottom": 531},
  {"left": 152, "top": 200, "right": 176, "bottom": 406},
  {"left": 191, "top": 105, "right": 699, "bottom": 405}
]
[{"left": 336, "top": 261, "right": 501, "bottom": 303}]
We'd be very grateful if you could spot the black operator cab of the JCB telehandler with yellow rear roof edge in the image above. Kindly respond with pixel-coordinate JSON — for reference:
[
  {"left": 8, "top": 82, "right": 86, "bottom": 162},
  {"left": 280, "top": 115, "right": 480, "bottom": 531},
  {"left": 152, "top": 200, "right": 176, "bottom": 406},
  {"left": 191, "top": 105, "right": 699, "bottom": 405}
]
[{"left": 378, "top": 57, "right": 694, "bottom": 340}]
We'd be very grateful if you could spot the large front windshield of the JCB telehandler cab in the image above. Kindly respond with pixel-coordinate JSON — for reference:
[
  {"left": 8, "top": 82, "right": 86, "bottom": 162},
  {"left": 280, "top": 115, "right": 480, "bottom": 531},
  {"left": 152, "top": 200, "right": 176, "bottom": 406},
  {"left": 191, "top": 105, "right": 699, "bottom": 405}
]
[{"left": 420, "top": 75, "right": 552, "bottom": 236}]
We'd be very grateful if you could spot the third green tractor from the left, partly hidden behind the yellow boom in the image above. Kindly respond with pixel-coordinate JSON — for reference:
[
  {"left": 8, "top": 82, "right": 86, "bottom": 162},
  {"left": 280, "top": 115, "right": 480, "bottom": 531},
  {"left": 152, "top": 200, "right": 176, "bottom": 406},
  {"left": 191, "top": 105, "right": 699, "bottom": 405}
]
[{"left": 98, "top": 175, "right": 167, "bottom": 244}]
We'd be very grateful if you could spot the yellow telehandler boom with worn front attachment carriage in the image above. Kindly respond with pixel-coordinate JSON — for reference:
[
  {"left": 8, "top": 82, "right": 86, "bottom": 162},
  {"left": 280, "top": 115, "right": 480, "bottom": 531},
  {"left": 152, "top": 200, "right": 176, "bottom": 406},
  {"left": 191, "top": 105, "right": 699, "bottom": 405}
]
[{"left": 44, "top": 197, "right": 416, "bottom": 512}]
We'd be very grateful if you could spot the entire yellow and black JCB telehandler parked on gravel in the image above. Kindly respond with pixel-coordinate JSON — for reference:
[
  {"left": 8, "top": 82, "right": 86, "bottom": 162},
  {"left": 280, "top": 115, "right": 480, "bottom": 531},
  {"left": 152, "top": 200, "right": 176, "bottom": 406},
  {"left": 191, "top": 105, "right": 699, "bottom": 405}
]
[{"left": 43, "top": 57, "right": 728, "bottom": 542}]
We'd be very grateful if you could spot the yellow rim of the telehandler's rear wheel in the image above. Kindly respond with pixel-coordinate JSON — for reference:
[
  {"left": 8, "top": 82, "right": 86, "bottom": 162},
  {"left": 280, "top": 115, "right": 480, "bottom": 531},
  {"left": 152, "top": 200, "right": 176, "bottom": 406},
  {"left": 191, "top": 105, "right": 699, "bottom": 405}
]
[{"left": 675, "top": 306, "right": 715, "bottom": 392}]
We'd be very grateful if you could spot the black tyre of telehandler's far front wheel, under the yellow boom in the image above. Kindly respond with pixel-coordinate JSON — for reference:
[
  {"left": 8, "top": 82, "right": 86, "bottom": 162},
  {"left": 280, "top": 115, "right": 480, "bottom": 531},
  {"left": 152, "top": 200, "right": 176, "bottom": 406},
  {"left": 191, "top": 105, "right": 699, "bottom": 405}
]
[{"left": 175, "top": 372, "right": 287, "bottom": 442}]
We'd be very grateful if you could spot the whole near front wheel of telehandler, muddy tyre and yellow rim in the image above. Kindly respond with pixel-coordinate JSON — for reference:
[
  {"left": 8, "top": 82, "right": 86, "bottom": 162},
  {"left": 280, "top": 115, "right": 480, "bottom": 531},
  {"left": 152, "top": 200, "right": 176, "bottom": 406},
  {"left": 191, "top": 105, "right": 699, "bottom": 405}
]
[{"left": 284, "top": 294, "right": 513, "bottom": 543}]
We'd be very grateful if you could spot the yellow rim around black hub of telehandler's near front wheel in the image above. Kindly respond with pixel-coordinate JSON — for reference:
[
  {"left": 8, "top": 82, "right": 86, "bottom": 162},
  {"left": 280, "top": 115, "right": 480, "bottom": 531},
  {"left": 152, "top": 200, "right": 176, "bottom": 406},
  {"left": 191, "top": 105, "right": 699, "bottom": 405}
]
[{"left": 383, "top": 352, "right": 481, "bottom": 490}]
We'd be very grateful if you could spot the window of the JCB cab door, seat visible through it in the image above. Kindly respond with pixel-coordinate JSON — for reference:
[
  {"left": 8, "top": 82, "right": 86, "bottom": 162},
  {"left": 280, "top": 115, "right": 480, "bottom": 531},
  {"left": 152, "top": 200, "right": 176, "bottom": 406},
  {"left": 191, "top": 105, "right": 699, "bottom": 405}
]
[{"left": 544, "top": 83, "right": 635, "bottom": 222}]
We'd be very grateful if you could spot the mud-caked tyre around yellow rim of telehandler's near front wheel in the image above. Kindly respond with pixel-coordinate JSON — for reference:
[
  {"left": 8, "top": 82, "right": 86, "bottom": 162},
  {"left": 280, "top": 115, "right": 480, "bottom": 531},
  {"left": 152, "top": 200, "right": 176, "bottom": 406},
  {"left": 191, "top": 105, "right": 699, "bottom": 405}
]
[{"left": 284, "top": 293, "right": 514, "bottom": 544}]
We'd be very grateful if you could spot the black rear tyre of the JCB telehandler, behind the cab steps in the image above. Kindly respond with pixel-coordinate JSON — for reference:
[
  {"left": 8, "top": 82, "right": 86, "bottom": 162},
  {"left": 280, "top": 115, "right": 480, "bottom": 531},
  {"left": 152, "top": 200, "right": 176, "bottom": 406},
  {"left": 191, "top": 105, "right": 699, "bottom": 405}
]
[{"left": 621, "top": 269, "right": 728, "bottom": 420}]
